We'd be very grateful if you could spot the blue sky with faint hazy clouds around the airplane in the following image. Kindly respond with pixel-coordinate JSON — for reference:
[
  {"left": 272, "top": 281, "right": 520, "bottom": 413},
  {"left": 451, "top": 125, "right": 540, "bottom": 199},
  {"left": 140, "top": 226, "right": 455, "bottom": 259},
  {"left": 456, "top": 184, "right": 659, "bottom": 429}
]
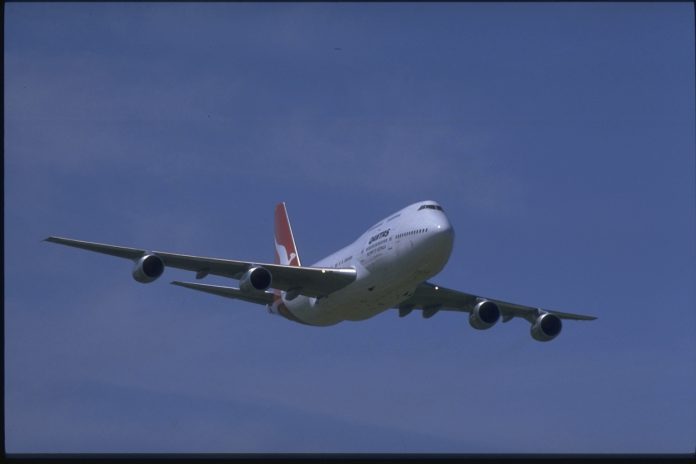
[{"left": 4, "top": 3, "right": 696, "bottom": 453}]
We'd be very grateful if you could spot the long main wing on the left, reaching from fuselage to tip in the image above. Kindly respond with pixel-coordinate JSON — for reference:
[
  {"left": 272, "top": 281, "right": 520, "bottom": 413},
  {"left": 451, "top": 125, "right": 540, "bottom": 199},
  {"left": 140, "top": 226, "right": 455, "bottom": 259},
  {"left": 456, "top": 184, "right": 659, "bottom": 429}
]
[{"left": 46, "top": 237, "right": 356, "bottom": 297}]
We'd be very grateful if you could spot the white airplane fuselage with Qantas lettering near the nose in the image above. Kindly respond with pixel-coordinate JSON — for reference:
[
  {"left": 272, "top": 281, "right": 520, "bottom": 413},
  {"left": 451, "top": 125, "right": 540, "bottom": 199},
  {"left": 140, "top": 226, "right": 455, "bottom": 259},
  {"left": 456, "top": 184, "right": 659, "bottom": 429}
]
[{"left": 269, "top": 201, "right": 454, "bottom": 326}]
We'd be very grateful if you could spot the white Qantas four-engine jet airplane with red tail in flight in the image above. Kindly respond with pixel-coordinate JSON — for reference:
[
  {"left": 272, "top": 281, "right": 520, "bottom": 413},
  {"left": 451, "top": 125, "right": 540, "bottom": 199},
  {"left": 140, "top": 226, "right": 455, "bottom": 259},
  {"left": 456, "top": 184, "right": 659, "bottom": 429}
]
[{"left": 45, "top": 201, "right": 596, "bottom": 342}]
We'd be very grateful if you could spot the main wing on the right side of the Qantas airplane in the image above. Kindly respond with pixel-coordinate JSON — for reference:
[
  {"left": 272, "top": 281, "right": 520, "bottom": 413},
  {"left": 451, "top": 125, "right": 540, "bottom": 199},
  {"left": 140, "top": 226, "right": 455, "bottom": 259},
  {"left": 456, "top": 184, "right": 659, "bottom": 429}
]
[{"left": 399, "top": 282, "right": 597, "bottom": 323}]
